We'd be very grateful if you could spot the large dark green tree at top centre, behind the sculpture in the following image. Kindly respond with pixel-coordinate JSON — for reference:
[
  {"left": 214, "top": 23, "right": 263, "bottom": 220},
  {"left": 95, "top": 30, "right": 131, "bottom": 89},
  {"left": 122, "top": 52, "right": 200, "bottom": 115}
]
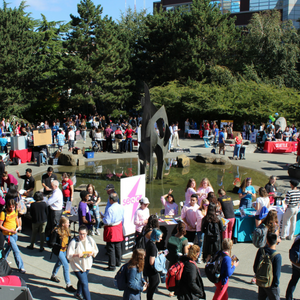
[{"left": 135, "top": 0, "right": 239, "bottom": 86}]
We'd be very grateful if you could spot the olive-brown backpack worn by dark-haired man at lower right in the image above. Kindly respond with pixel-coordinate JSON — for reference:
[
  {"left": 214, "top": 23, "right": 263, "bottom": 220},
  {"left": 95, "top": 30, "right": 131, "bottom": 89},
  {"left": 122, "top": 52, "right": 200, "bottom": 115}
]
[{"left": 255, "top": 249, "right": 278, "bottom": 288}]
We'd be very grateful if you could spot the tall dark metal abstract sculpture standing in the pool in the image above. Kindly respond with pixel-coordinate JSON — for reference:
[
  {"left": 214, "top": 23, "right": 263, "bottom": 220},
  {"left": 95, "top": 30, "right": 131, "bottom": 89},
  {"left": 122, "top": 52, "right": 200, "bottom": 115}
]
[{"left": 139, "top": 83, "right": 171, "bottom": 182}]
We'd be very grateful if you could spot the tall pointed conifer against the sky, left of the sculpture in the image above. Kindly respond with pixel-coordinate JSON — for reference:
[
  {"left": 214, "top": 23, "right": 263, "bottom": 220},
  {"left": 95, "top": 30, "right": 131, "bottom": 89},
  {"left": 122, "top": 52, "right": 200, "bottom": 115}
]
[{"left": 64, "top": 0, "right": 131, "bottom": 112}]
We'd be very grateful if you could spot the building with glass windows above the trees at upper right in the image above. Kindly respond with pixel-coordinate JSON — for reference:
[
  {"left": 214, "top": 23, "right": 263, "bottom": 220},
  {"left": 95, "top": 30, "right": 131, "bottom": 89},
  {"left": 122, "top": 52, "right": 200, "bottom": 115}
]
[{"left": 153, "top": 0, "right": 300, "bottom": 28}]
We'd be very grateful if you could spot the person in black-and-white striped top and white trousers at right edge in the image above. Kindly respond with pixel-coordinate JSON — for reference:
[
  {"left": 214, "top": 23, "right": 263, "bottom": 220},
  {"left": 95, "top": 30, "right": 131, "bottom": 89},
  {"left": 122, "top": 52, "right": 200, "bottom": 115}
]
[{"left": 281, "top": 180, "right": 300, "bottom": 240}]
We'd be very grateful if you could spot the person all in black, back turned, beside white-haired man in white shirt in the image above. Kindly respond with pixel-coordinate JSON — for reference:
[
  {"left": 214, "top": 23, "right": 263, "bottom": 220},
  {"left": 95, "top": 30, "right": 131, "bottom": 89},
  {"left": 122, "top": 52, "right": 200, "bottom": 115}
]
[{"left": 27, "top": 192, "right": 48, "bottom": 252}]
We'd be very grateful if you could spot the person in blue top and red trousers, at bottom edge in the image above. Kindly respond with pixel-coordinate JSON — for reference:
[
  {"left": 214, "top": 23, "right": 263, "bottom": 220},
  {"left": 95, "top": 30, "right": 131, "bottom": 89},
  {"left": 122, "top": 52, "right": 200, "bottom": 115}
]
[{"left": 213, "top": 238, "right": 239, "bottom": 300}]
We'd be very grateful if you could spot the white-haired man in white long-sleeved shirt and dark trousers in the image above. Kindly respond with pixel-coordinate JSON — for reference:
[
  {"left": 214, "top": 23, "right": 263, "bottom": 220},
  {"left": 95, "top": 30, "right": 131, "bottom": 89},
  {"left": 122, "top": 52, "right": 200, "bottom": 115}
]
[{"left": 47, "top": 180, "right": 63, "bottom": 233}]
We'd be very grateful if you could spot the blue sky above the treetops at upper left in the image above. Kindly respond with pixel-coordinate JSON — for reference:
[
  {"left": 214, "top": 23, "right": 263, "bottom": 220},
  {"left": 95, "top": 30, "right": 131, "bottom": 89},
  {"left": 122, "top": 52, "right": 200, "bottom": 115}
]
[{"left": 12, "top": 0, "right": 154, "bottom": 22}]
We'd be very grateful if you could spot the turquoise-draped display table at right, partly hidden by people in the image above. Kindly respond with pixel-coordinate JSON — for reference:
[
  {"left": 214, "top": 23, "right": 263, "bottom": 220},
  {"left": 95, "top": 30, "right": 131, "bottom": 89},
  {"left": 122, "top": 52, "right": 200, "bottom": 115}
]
[{"left": 232, "top": 205, "right": 300, "bottom": 242}]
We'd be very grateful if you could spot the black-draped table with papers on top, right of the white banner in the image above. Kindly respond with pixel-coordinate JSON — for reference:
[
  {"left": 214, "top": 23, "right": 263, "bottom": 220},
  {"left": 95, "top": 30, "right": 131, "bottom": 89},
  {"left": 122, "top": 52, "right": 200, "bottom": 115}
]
[{"left": 156, "top": 216, "right": 181, "bottom": 250}]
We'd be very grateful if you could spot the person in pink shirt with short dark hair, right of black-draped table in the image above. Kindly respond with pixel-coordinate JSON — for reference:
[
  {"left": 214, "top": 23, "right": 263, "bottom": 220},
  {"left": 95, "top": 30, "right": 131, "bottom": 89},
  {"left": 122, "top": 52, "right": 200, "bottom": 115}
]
[{"left": 181, "top": 194, "right": 199, "bottom": 243}]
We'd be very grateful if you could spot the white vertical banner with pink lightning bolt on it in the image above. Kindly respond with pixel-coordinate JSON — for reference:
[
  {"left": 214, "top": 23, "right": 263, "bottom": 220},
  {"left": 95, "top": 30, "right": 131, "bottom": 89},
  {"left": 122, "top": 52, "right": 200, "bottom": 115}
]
[{"left": 120, "top": 174, "right": 146, "bottom": 254}]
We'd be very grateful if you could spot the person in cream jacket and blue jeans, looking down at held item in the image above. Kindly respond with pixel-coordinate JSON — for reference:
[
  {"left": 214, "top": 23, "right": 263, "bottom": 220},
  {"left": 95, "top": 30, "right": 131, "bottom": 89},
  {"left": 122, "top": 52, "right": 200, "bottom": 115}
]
[{"left": 67, "top": 225, "right": 98, "bottom": 300}]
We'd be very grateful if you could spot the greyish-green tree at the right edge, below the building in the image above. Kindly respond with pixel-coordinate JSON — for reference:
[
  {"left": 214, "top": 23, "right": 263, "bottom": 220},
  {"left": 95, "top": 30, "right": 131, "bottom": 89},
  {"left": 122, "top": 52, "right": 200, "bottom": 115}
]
[{"left": 240, "top": 10, "right": 300, "bottom": 89}]
